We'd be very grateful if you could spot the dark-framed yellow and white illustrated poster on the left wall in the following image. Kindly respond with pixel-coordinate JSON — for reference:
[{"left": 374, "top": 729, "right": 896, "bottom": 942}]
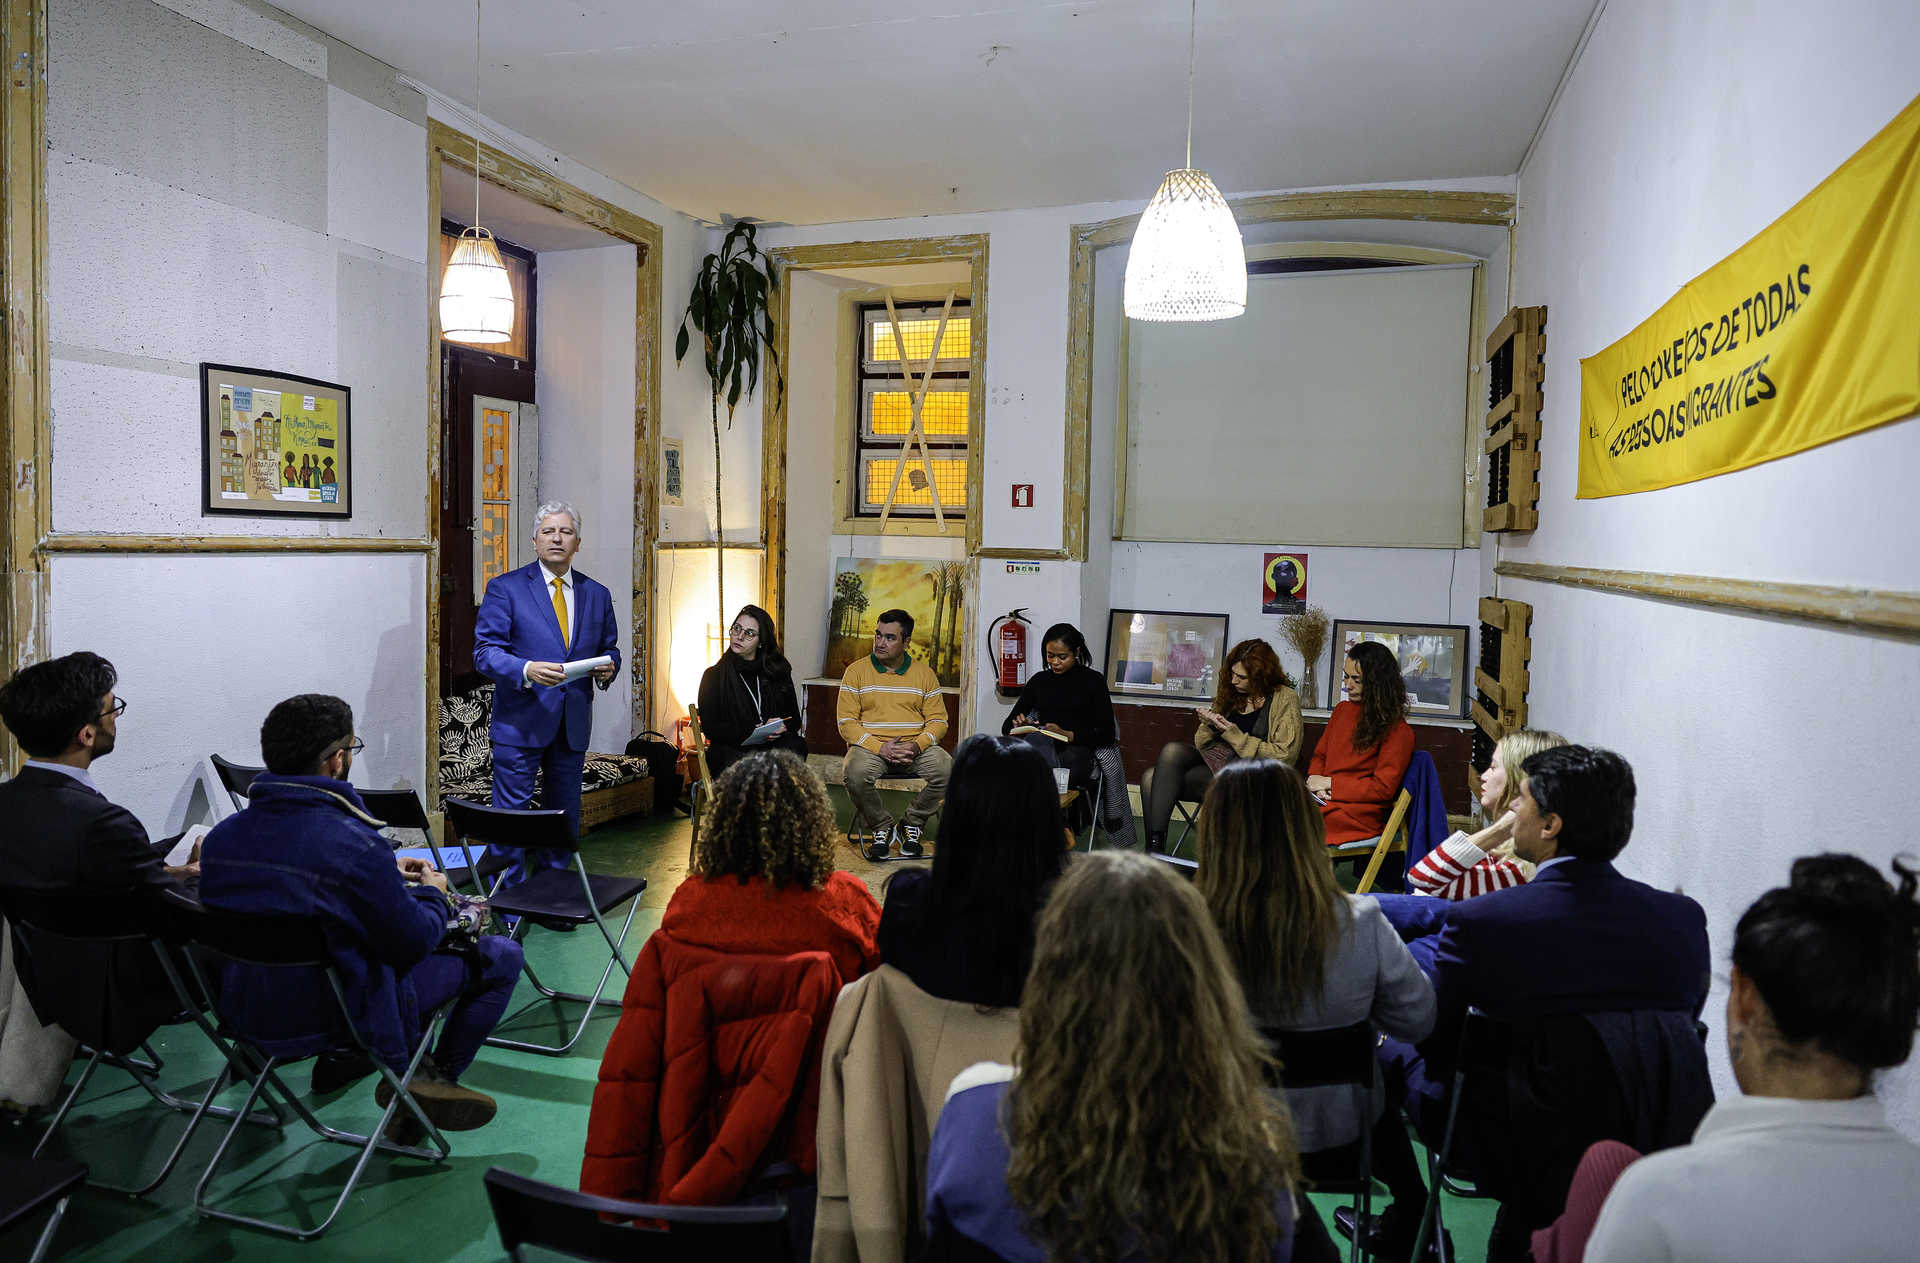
[{"left": 200, "top": 365, "right": 353, "bottom": 518}]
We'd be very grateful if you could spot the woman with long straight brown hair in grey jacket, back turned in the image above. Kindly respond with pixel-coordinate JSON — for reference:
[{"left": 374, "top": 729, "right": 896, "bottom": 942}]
[{"left": 1194, "top": 758, "right": 1434, "bottom": 1205}]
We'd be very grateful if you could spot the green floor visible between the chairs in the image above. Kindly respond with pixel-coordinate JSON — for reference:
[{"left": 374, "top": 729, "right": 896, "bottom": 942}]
[{"left": 0, "top": 789, "right": 1492, "bottom": 1263}]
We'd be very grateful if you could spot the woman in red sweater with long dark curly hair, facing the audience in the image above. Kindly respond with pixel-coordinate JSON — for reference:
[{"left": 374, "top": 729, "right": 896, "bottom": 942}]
[{"left": 1308, "top": 641, "right": 1413, "bottom": 846}]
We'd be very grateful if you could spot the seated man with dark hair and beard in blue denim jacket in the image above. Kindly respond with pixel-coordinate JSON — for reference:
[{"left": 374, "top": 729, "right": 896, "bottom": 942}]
[{"left": 200, "top": 693, "right": 520, "bottom": 1131}]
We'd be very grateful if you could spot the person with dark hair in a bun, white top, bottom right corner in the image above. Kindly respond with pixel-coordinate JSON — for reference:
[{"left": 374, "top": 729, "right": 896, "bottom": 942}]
[{"left": 1582, "top": 854, "right": 1920, "bottom": 1263}]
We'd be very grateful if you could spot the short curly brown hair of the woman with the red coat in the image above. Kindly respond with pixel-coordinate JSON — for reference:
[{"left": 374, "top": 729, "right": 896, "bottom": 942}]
[{"left": 691, "top": 751, "right": 835, "bottom": 891}]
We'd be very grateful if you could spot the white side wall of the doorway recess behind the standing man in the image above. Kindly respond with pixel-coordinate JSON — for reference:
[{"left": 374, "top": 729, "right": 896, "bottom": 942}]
[{"left": 534, "top": 242, "right": 636, "bottom": 751}]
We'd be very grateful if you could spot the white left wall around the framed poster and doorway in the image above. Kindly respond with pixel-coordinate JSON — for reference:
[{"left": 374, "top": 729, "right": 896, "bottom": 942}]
[{"left": 46, "top": 0, "right": 710, "bottom": 821}]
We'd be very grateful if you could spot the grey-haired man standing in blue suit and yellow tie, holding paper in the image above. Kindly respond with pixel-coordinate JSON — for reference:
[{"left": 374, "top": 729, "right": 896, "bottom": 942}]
[{"left": 474, "top": 501, "right": 620, "bottom": 885}]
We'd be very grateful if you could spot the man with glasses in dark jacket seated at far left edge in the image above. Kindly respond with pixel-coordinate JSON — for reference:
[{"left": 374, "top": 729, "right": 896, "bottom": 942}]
[{"left": 0, "top": 651, "right": 198, "bottom": 1048}]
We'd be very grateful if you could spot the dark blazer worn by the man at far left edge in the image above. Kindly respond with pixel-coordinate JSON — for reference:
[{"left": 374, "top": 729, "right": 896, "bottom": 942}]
[{"left": 0, "top": 768, "right": 184, "bottom": 1052}]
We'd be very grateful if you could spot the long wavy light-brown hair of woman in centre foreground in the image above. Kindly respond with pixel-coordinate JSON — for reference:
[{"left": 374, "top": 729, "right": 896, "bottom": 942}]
[{"left": 1004, "top": 852, "right": 1300, "bottom": 1263}]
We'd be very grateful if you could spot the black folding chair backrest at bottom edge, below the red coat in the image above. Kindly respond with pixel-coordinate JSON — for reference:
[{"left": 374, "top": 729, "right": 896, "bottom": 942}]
[{"left": 486, "top": 1167, "right": 791, "bottom": 1263}]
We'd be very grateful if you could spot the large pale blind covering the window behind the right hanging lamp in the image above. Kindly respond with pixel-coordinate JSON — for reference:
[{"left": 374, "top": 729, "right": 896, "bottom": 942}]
[{"left": 1121, "top": 265, "right": 1473, "bottom": 547}]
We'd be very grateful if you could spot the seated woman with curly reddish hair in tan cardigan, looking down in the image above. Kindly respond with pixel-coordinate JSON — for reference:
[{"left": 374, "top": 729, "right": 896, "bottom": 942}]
[{"left": 1140, "top": 639, "right": 1302, "bottom": 850}]
